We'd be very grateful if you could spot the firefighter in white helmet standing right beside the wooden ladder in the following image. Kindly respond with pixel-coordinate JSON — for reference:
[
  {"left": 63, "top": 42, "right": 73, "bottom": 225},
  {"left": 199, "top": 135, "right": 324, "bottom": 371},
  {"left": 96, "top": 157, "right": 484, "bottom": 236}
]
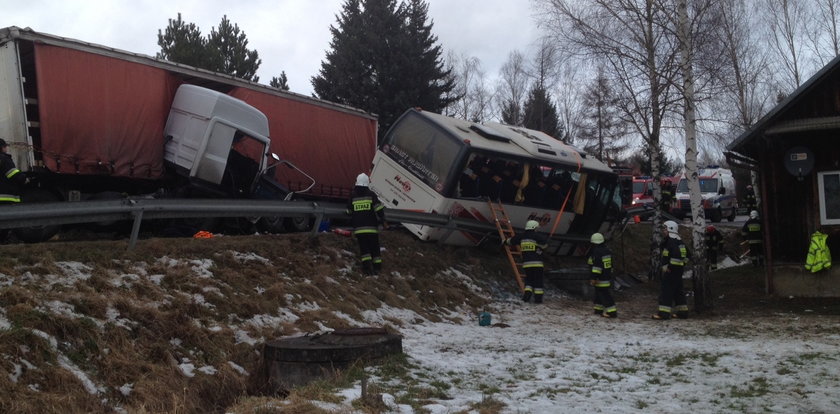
[{"left": 504, "top": 220, "right": 546, "bottom": 303}]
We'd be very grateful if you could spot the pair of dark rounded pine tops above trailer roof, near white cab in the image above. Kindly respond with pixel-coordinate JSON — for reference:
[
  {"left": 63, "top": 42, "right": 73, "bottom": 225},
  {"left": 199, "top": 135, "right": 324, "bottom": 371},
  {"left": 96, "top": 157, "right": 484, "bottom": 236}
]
[{"left": 157, "top": 13, "right": 262, "bottom": 82}]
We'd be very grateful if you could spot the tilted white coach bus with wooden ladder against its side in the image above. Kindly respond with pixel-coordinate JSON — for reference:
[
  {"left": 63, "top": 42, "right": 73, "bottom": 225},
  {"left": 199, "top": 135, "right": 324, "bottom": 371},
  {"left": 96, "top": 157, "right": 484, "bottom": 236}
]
[{"left": 371, "top": 109, "right": 621, "bottom": 255}]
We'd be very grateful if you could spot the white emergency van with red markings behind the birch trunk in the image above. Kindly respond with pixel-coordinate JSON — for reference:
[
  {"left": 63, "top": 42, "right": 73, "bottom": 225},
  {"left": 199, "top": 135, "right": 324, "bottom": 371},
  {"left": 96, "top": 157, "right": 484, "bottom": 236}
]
[{"left": 674, "top": 166, "right": 738, "bottom": 223}]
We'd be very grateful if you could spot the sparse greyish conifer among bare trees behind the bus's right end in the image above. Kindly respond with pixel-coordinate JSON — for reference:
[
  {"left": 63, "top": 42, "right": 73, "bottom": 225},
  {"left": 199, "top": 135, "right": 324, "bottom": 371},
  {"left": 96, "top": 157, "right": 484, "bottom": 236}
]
[{"left": 577, "top": 69, "right": 627, "bottom": 161}]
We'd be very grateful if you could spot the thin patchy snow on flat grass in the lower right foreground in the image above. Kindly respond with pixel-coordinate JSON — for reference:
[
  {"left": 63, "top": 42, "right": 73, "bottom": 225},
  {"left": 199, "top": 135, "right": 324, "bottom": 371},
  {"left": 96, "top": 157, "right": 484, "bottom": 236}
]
[{"left": 343, "top": 297, "right": 840, "bottom": 414}]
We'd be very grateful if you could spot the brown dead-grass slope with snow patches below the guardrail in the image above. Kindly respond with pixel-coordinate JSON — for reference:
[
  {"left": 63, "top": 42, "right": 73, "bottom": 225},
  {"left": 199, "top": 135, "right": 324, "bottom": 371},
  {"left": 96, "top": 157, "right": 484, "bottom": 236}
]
[{"left": 0, "top": 227, "right": 836, "bottom": 413}]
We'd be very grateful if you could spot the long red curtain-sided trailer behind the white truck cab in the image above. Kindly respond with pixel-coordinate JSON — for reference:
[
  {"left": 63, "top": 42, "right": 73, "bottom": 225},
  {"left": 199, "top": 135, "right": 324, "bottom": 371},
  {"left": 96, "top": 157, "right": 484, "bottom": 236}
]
[{"left": 0, "top": 27, "right": 377, "bottom": 239}]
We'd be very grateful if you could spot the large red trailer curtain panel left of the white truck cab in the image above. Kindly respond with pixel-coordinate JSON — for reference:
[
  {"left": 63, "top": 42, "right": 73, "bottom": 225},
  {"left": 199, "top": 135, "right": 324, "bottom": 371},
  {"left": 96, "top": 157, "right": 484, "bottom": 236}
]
[{"left": 35, "top": 44, "right": 180, "bottom": 179}]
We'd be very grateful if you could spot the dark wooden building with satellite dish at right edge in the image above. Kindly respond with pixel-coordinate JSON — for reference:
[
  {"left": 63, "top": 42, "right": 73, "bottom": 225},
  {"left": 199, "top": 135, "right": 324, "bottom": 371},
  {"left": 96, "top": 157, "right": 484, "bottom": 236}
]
[{"left": 727, "top": 57, "right": 840, "bottom": 297}]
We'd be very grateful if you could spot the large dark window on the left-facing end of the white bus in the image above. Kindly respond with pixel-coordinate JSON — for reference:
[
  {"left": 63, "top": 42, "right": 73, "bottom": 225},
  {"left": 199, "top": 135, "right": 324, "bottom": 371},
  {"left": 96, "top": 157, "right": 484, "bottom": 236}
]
[{"left": 382, "top": 113, "right": 464, "bottom": 193}]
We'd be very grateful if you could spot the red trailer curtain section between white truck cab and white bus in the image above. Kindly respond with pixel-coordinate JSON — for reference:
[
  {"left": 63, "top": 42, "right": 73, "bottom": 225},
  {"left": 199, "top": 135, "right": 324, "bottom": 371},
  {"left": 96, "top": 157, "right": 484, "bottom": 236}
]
[{"left": 230, "top": 88, "right": 376, "bottom": 197}]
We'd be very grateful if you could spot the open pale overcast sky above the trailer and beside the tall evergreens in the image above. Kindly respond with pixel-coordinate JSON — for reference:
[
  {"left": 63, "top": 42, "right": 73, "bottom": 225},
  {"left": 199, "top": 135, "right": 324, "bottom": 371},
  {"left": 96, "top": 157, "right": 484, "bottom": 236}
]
[{"left": 0, "top": 0, "right": 539, "bottom": 95}]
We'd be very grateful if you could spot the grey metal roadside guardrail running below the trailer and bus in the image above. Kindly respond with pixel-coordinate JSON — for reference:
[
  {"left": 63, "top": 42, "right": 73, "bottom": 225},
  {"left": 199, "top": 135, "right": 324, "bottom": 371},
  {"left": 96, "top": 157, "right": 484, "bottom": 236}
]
[{"left": 0, "top": 198, "right": 588, "bottom": 249}]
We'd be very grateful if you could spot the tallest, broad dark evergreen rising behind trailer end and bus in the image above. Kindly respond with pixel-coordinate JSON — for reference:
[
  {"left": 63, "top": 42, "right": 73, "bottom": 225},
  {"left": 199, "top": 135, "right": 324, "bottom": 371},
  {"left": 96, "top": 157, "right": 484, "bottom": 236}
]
[{"left": 312, "top": 0, "right": 453, "bottom": 141}]
